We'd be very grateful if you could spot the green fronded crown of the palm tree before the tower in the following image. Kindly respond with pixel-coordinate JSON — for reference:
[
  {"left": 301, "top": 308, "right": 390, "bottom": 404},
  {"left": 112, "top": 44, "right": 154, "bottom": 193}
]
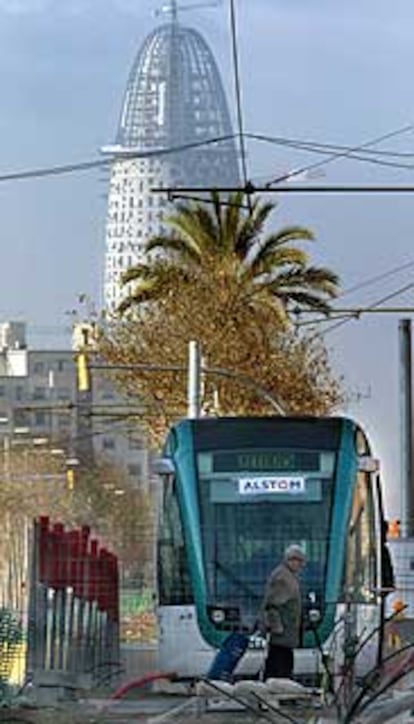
[{"left": 119, "top": 192, "right": 339, "bottom": 320}]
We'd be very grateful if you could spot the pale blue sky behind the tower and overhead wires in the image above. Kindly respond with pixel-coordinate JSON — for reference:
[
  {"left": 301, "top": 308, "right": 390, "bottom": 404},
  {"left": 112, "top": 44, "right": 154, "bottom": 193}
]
[{"left": 0, "top": 0, "right": 414, "bottom": 514}]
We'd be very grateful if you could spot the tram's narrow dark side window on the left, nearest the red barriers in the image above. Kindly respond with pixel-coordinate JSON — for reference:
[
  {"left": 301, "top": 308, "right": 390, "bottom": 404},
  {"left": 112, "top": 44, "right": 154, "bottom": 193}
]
[{"left": 157, "top": 480, "right": 193, "bottom": 606}]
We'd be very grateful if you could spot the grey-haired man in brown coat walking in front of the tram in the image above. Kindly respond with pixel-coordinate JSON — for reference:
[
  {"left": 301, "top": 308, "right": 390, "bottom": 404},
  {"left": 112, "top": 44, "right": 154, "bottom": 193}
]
[{"left": 260, "top": 545, "right": 306, "bottom": 679}]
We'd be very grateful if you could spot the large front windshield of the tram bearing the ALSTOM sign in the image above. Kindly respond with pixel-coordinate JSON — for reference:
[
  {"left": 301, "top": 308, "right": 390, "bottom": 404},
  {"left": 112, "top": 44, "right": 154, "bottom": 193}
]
[{"left": 197, "top": 448, "right": 336, "bottom": 627}]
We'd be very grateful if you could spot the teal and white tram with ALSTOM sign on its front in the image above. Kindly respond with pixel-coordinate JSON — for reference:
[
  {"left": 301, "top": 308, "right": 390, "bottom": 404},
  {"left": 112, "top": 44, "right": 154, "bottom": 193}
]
[{"left": 156, "top": 417, "right": 385, "bottom": 681}]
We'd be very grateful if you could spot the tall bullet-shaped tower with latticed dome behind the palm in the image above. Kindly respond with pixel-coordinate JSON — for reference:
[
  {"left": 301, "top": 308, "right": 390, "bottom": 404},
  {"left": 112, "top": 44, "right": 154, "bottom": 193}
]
[{"left": 102, "top": 2, "right": 239, "bottom": 312}]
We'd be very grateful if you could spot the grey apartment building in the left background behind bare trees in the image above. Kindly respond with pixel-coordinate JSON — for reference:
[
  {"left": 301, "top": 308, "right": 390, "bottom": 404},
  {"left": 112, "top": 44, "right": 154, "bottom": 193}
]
[{"left": 0, "top": 321, "right": 149, "bottom": 487}]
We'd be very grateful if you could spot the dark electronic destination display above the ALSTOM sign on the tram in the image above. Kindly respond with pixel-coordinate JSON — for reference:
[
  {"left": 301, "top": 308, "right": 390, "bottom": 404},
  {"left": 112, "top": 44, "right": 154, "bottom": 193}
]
[{"left": 213, "top": 449, "right": 320, "bottom": 473}]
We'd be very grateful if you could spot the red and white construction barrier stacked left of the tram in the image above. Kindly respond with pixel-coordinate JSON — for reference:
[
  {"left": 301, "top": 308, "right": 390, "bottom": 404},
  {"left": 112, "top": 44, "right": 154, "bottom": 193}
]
[{"left": 27, "top": 517, "right": 119, "bottom": 688}]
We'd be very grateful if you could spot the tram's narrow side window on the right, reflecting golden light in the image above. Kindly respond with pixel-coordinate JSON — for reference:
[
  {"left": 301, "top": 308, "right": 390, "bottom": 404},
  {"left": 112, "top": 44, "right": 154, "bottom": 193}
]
[{"left": 346, "top": 472, "right": 377, "bottom": 603}]
